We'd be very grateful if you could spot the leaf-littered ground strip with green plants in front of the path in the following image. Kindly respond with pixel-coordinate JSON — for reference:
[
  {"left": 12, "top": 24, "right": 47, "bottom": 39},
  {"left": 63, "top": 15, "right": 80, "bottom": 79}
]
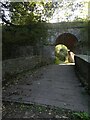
[{"left": 2, "top": 101, "right": 90, "bottom": 120}]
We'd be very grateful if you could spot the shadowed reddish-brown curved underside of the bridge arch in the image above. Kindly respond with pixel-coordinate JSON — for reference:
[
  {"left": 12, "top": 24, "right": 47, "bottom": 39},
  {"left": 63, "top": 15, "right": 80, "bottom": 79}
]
[{"left": 55, "top": 33, "right": 78, "bottom": 52}]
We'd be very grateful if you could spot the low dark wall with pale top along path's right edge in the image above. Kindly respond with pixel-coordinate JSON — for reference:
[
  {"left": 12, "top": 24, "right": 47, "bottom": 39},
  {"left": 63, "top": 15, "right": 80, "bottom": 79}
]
[{"left": 75, "top": 55, "right": 90, "bottom": 92}]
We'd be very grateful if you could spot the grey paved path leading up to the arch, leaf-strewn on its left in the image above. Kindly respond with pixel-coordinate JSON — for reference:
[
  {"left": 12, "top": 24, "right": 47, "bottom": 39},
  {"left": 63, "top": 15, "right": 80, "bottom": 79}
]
[{"left": 3, "top": 65, "right": 90, "bottom": 112}]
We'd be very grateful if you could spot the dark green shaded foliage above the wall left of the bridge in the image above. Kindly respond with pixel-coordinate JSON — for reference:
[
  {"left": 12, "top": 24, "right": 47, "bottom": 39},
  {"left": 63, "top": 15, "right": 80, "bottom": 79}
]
[{"left": 2, "top": 23, "right": 47, "bottom": 46}]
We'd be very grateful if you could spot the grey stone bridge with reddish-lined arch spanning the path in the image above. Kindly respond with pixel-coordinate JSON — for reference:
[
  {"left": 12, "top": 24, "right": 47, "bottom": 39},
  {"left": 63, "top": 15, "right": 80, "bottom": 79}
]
[{"left": 38, "top": 22, "right": 89, "bottom": 58}]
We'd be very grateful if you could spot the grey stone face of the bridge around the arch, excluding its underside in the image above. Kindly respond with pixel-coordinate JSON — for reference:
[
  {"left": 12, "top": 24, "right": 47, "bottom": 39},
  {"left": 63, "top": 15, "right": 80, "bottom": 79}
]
[{"left": 47, "top": 23, "right": 90, "bottom": 55}]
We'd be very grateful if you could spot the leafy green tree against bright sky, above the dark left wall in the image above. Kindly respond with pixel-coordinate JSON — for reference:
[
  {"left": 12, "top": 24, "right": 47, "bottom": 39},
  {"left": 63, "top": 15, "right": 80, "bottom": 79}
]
[{"left": 0, "top": 1, "right": 57, "bottom": 25}]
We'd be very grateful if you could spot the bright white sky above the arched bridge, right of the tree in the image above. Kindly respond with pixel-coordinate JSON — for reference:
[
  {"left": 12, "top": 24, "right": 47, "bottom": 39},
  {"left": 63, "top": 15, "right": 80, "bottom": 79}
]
[{"left": 1, "top": 0, "right": 90, "bottom": 23}]
